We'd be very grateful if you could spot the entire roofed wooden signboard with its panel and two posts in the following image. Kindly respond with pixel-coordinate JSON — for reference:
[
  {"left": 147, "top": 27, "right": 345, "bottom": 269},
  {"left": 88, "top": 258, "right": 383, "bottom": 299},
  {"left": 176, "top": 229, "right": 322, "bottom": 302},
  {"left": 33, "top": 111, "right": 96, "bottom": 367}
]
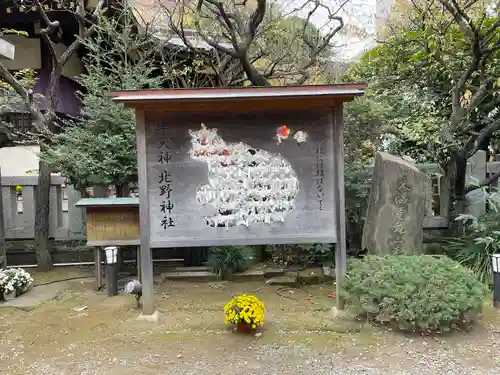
[{"left": 113, "top": 85, "right": 364, "bottom": 314}]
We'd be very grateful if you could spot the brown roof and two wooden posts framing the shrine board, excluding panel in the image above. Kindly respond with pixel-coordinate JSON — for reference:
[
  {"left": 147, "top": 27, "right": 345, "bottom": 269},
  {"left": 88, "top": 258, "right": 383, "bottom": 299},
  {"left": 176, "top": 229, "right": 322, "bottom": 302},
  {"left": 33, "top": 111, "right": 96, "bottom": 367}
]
[{"left": 112, "top": 84, "right": 365, "bottom": 315}]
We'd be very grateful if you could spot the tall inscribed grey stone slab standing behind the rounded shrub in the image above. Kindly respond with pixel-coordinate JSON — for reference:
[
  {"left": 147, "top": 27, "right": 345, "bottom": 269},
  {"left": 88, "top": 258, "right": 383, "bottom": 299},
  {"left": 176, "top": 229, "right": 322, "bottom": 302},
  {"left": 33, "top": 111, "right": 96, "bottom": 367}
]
[{"left": 362, "top": 152, "right": 430, "bottom": 255}]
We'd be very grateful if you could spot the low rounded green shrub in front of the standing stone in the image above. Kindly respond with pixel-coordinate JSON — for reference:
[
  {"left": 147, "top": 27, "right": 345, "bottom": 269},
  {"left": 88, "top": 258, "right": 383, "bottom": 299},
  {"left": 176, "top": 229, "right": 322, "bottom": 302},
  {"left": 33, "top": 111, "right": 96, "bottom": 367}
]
[{"left": 342, "top": 255, "right": 485, "bottom": 333}]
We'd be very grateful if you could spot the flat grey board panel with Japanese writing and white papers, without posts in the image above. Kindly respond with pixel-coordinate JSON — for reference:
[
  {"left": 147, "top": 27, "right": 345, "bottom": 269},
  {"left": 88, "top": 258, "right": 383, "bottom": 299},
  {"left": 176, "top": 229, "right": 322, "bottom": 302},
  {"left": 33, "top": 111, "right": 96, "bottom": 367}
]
[{"left": 145, "top": 109, "right": 336, "bottom": 247}]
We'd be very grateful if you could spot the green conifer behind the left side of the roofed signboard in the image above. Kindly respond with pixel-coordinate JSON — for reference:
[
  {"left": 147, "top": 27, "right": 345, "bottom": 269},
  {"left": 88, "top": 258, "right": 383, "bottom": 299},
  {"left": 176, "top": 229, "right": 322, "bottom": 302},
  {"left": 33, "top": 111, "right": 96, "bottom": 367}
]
[{"left": 41, "top": 9, "right": 165, "bottom": 192}]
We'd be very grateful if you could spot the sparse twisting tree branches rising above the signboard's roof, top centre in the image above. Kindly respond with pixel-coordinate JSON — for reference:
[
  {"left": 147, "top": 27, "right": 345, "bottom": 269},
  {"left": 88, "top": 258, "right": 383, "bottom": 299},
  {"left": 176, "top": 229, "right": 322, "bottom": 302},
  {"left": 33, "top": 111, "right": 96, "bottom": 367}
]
[{"left": 162, "top": 0, "right": 347, "bottom": 86}]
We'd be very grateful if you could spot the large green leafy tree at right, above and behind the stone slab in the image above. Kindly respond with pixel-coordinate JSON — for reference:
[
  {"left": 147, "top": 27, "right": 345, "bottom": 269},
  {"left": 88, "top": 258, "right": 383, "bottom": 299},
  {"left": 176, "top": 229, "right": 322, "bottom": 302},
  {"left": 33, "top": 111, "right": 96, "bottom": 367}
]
[{"left": 348, "top": 0, "right": 500, "bottom": 229}]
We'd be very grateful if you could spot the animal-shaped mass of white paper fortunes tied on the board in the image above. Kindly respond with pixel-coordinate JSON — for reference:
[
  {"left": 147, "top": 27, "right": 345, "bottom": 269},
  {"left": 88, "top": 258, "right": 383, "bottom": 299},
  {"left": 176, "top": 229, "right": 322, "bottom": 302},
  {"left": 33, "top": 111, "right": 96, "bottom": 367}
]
[{"left": 189, "top": 125, "right": 299, "bottom": 228}]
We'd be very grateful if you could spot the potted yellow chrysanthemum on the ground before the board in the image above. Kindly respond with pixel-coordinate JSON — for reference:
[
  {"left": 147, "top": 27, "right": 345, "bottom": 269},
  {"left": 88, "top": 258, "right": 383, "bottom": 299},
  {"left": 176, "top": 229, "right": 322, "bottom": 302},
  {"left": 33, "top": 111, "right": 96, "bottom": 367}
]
[{"left": 224, "top": 294, "right": 266, "bottom": 332}]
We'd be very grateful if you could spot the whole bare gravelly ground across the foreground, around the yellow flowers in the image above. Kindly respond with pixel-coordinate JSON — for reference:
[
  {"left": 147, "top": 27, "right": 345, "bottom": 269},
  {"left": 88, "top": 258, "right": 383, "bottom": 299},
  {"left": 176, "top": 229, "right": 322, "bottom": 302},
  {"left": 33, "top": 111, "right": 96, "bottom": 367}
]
[{"left": 0, "top": 276, "right": 500, "bottom": 375}]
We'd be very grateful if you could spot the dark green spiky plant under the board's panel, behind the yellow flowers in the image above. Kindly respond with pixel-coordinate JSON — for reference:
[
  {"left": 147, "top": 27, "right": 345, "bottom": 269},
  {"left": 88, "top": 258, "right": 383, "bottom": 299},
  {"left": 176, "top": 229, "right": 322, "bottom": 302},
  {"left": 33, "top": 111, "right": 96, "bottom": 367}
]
[{"left": 207, "top": 246, "right": 254, "bottom": 280}]
